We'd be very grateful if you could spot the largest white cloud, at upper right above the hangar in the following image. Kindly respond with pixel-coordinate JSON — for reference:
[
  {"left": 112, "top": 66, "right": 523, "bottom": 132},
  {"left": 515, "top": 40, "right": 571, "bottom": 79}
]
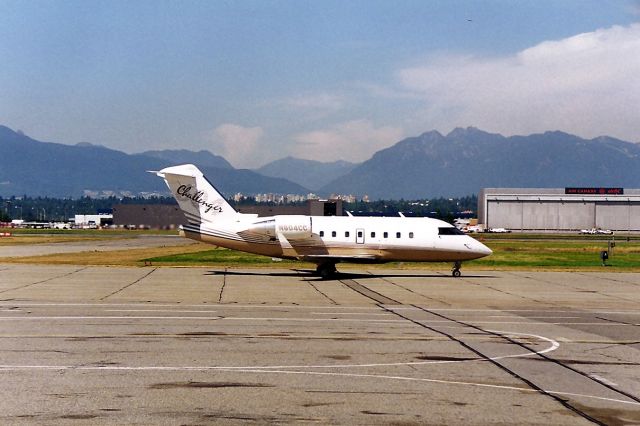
[{"left": 397, "top": 24, "right": 640, "bottom": 141}]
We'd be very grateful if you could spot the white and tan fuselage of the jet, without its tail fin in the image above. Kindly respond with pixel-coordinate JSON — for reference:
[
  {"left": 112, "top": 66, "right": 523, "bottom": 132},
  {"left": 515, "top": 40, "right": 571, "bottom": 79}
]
[{"left": 184, "top": 214, "right": 491, "bottom": 263}]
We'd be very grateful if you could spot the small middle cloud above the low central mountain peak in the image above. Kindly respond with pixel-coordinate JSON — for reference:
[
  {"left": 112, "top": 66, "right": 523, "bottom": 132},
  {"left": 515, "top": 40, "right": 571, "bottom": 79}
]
[{"left": 292, "top": 120, "right": 402, "bottom": 161}]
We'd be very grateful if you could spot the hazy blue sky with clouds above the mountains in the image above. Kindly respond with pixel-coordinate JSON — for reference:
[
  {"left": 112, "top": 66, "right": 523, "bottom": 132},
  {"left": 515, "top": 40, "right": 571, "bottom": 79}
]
[{"left": 0, "top": 0, "right": 640, "bottom": 167}]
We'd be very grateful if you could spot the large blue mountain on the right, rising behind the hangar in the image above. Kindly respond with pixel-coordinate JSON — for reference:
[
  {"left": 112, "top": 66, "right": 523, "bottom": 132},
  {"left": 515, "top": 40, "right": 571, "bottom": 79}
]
[{"left": 320, "top": 127, "right": 640, "bottom": 199}]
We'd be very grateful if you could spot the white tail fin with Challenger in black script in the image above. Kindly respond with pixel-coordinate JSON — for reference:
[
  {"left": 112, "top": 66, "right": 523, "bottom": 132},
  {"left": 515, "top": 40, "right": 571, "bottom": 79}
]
[{"left": 155, "top": 164, "right": 239, "bottom": 225}]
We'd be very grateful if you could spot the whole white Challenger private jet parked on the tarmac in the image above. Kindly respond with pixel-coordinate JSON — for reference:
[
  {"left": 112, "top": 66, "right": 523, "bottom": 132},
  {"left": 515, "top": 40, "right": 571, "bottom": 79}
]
[{"left": 154, "top": 164, "right": 492, "bottom": 278}]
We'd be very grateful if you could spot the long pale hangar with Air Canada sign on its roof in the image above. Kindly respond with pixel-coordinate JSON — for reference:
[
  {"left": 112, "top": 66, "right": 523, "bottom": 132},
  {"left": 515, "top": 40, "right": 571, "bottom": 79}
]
[{"left": 478, "top": 188, "right": 640, "bottom": 232}]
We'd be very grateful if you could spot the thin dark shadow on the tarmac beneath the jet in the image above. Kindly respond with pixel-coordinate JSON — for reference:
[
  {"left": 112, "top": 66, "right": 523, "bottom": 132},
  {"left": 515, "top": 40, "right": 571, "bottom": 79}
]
[{"left": 205, "top": 269, "right": 497, "bottom": 281}]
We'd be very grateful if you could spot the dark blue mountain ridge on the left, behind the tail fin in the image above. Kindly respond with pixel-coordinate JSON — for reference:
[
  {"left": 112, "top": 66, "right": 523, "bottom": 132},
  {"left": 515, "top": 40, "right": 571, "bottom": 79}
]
[{"left": 0, "top": 126, "right": 308, "bottom": 197}]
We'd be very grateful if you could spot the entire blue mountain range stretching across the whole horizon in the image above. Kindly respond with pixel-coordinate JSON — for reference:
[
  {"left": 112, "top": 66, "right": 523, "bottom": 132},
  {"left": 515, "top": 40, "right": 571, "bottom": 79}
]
[{"left": 0, "top": 126, "right": 640, "bottom": 199}]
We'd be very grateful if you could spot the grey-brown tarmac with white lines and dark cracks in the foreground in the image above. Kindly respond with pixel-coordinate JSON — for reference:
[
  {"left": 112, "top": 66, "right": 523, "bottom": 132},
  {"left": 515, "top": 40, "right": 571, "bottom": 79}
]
[{"left": 0, "top": 264, "right": 640, "bottom": 425}]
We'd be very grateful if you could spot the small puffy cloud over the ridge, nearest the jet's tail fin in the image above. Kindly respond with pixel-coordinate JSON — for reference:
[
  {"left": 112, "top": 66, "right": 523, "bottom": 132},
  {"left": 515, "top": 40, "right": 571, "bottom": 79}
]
[{"left": 211, "top": 123, "right": 264, "bottom": 167}]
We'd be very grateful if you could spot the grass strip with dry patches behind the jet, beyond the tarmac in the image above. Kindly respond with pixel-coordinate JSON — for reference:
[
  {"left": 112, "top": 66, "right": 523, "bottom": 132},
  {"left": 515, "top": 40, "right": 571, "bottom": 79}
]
[{"left": 0, "top": 230, "right": 640, "bottom": 272}]
